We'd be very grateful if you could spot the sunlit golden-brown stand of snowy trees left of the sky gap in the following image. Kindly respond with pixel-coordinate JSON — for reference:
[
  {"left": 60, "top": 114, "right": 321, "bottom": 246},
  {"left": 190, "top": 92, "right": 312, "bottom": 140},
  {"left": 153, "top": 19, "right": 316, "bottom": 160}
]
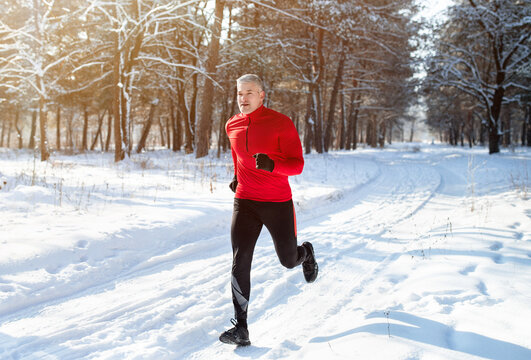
[{"left": 0, "top": 0, "right": 420, "bottom": 161}]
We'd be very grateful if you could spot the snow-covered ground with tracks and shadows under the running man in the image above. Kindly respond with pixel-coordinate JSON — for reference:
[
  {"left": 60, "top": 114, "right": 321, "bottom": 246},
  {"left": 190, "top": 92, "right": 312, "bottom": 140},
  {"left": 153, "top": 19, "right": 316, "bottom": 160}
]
[{"left": 0, "top": 144, "right": 531, "bottom": 360}]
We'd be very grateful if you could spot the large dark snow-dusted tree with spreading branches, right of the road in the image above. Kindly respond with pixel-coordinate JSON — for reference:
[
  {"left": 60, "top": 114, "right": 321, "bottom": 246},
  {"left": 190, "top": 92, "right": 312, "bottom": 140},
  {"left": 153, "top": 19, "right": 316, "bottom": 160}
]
[{"left": 428, "top": 0, "right": 531, "bottom": 154}]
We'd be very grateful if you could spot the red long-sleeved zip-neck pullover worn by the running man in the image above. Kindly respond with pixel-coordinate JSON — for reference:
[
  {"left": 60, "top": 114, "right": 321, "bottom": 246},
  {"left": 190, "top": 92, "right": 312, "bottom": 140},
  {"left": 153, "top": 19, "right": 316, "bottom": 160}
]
[{"left": 225, "top": 105, "right": 304, "bottom": 202}]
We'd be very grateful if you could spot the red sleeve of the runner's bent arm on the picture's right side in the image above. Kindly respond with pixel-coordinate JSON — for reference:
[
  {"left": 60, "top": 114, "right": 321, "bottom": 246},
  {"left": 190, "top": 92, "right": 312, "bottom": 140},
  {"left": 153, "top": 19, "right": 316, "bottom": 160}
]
[{"left": 270, "top": 118, "right": 304, "bottom": 176}]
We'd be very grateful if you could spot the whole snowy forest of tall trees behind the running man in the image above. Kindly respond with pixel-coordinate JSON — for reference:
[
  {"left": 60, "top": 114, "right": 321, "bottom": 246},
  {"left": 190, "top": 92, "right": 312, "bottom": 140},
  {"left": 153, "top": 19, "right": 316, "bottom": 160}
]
[{"left": 0, "top": 0, "right": 531, "bottom": 161}]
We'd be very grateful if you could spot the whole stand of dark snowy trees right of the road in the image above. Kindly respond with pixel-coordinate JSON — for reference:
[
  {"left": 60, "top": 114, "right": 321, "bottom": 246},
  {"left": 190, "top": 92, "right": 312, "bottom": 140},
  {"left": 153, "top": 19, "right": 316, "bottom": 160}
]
[{"left": 423, "top": 0, "right": 531, "bottom": 154}]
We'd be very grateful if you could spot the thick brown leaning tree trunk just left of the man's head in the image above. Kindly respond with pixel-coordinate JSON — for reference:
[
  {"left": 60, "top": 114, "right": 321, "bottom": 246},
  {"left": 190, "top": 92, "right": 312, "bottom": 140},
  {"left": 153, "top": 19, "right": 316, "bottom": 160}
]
[{"left": 195, "top": 0, "right": 225, "bottom": 158}]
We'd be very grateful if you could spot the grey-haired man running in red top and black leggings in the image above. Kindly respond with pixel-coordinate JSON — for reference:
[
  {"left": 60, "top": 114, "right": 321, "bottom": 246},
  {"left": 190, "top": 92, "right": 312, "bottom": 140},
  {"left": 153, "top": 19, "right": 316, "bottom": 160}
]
[{"left": 219, "top": 74, "right": 318, "bottom": 346}]
